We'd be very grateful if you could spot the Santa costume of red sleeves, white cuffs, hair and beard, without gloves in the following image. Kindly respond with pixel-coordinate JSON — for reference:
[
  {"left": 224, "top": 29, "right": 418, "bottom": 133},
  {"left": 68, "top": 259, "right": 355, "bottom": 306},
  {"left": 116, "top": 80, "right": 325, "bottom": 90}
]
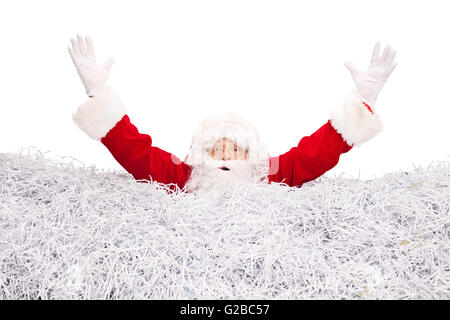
[{"left": 73, "top": 87, "right": 382, "bottom": 191}]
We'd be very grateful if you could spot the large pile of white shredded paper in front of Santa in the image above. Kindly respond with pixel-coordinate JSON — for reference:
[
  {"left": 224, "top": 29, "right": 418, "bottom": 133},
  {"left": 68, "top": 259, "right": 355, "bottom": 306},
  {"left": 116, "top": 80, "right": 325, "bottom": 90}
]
[{"left": 0, "top": 151, "right": 450, "bottom": 300}]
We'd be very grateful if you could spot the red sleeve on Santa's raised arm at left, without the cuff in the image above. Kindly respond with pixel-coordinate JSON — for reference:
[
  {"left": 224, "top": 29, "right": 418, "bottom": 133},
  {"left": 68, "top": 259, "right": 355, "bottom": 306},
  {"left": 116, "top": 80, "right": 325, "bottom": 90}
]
[{"left": 101, "top": 115, "right": 192, "bottom": 190}]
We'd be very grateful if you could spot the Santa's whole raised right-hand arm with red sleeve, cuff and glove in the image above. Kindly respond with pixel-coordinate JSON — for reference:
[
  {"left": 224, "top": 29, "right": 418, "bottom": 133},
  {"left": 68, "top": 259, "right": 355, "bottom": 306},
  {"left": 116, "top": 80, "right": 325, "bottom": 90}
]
[{"left": 268, "top": 43, "right": 396, "bottom": 187}]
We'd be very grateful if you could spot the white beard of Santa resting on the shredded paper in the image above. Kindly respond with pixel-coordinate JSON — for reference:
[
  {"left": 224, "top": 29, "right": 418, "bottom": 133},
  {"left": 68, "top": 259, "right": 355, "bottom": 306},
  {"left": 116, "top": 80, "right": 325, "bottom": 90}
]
[{"left": 186, "top": 156, "right": 264, "bottom": 192}]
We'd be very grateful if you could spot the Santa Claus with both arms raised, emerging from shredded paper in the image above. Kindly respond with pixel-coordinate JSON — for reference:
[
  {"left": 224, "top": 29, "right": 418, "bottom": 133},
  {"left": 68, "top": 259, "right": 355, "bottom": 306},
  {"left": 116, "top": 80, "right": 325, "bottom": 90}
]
[{"left": 69, "top": 35, "right": 396, "bottom": 191}]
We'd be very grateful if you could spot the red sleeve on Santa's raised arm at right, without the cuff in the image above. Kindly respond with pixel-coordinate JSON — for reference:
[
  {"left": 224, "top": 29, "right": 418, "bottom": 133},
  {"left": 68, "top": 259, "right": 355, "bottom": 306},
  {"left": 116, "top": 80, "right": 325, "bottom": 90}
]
[{"left": 268, "top": 121, "right": 352, "bottom": 187}]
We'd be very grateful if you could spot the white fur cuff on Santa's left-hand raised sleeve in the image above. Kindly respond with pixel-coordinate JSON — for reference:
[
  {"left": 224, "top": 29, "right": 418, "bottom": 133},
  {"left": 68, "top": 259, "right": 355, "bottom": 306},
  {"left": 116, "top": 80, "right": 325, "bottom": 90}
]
[{"left": 72, "top": 87, "right": 126, "bottom": 140}]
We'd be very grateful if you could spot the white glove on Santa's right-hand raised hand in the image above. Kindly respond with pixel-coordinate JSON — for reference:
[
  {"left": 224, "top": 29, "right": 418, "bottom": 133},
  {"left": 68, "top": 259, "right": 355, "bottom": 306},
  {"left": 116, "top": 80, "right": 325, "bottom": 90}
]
[{"left": 344, "top": 42, "right": 397, "bottom": 106}]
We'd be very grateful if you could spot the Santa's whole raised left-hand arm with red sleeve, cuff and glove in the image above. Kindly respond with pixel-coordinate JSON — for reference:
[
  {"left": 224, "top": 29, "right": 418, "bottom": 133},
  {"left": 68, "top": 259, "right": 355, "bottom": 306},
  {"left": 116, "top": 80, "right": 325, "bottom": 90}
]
[{"left": 69, "top": 36, "right": 192, "bottom": 190}]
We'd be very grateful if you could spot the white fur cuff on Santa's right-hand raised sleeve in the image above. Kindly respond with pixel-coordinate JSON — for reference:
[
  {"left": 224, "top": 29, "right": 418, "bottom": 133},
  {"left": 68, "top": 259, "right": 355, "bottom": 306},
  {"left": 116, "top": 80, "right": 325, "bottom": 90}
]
[{"left": 330, "top": 91, "right": 383, "bottom": 146}]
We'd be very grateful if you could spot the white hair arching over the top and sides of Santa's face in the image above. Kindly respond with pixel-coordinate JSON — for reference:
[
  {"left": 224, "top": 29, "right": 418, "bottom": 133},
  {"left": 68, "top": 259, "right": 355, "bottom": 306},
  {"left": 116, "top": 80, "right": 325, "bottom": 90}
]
[{"left": 184, "top": 112, "right": 269, "bottom": 170}]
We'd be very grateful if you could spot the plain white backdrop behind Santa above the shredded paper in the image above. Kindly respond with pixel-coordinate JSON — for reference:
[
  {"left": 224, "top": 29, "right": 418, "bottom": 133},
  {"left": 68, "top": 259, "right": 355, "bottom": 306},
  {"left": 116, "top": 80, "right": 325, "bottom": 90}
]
[{"left": 0, "top": 0, "right": 450, "bottom": 179}]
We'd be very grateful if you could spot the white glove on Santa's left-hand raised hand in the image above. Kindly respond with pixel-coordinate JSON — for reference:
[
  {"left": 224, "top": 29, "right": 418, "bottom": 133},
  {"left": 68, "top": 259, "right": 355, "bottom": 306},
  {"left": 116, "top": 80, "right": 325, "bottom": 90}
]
[{"left": 69, "top": 35, "right": 114, "bottom": 96}]
